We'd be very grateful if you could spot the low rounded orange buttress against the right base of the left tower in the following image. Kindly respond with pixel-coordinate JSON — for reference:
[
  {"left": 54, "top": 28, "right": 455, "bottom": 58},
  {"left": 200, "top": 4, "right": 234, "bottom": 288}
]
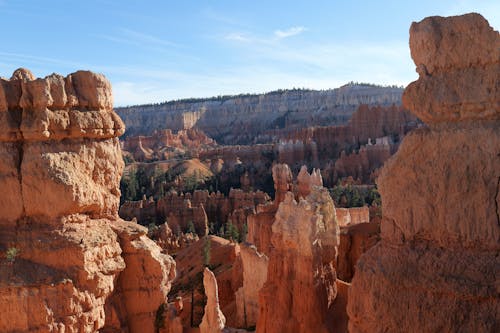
[{"left": 103, "top": 221, "right": 176, "bottom": 332}]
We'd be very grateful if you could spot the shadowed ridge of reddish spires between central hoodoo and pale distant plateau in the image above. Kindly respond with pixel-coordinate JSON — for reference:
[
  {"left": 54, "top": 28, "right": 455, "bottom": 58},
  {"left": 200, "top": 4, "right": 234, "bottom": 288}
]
[{"left": 199, "top": 105, "right": 419, "bottom": 189}]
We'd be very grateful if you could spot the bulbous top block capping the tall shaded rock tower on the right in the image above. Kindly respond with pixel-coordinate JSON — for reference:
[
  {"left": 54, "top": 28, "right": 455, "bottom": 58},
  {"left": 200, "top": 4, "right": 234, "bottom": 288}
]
[{"left": 403, "top": 14, "right": 500, "bottom": 124}]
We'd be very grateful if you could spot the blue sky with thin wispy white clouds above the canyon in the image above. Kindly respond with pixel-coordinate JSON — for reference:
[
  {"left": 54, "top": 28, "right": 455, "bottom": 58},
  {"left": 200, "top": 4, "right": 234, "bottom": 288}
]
[{"left": 0, "top": 0, "right": 500, "bottom": 106}]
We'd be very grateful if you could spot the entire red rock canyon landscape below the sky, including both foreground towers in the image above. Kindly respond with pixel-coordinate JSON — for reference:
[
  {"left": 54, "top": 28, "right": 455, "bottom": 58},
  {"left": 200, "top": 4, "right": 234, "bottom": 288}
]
[{"left": 0, "top": 13, "right": 500, "bottom": 333}]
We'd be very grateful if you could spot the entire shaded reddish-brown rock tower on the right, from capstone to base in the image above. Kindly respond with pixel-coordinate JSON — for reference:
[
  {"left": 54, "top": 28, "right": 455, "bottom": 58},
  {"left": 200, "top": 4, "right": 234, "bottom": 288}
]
[{"left": 348, "top": 14, "right": 500, "bottom": 332}]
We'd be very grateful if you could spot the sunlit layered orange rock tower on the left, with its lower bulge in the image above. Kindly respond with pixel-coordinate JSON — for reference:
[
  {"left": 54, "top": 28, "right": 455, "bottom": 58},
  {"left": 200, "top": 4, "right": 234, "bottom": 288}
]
[{"left": 0, "top": 69, "right": 175, "bottom": 332}]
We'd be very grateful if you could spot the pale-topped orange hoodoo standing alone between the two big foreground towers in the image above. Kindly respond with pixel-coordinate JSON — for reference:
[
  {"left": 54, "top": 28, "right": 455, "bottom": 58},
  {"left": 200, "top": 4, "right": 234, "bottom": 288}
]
[{"left": 257, "top": 170, "right": 339, "bottom": 332}]
